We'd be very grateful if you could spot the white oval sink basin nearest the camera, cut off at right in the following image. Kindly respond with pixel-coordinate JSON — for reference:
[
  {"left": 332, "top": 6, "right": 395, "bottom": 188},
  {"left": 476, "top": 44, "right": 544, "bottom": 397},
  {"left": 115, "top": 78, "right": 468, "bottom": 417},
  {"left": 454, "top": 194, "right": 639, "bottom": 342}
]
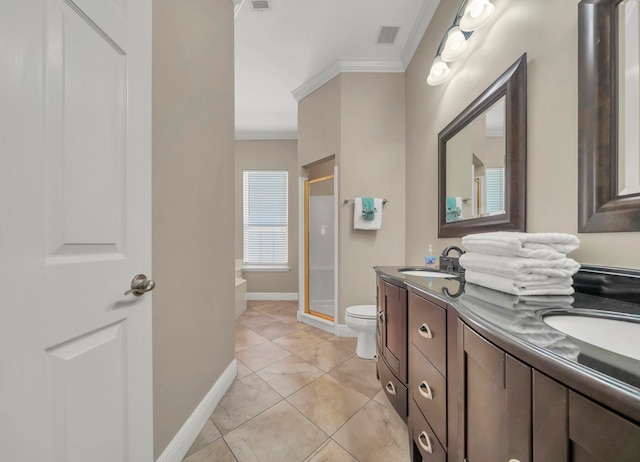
[{"left": 543, "top": 314, "right": 640, "bottom": 361}]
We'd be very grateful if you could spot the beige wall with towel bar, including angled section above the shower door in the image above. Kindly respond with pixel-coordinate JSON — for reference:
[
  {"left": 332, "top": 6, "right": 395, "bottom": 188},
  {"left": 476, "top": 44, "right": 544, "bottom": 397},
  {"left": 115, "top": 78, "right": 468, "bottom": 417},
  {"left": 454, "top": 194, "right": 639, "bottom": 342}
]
[{"left": 298, "top": 73, "right": 405, "bottom": 323}]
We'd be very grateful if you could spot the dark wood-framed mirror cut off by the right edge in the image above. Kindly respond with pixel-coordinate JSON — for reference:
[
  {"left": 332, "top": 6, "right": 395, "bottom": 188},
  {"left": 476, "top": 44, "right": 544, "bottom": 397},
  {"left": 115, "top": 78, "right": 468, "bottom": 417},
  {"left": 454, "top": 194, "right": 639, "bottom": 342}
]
[{"left": 578, "top": 0, "right": 640, "bottom": 233}]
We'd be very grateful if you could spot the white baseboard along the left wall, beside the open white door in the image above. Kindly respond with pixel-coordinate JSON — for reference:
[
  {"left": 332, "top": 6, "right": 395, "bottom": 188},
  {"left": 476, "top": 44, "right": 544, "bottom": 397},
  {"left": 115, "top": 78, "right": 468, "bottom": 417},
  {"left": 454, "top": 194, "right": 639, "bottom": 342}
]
[{"left": 156, "top": 358, "right": 238, "bottom": 462}]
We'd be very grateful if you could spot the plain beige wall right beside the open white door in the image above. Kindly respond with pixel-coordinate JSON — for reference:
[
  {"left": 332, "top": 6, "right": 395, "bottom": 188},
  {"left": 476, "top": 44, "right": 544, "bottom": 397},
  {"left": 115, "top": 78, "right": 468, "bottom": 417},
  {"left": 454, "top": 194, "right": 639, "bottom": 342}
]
[{"left": 152, "top": 0, "right": 235, "bottom": 458}]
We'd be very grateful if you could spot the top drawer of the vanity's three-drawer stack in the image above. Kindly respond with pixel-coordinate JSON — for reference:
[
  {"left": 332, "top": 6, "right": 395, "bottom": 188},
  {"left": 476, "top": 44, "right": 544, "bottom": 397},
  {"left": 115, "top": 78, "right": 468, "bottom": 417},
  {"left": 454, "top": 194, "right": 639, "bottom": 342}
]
[{"left": 409, "top": 293, "right": 447, "bottom": 377}]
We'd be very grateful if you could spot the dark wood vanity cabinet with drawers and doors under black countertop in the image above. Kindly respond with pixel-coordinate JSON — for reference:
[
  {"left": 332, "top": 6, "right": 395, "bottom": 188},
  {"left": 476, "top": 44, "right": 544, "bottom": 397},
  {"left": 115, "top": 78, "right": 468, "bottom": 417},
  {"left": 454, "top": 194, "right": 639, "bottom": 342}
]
[{"left": 376, "top": 268, "right": 640, "bottom": 462}]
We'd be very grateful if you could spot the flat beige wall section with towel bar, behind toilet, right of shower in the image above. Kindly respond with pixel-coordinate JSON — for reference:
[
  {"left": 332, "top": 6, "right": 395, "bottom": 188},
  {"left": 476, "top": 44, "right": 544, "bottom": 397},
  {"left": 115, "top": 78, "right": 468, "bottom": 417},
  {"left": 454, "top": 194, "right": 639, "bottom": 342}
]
[{"left": 338, "top": 73, "right": 406, "bottom": 323}]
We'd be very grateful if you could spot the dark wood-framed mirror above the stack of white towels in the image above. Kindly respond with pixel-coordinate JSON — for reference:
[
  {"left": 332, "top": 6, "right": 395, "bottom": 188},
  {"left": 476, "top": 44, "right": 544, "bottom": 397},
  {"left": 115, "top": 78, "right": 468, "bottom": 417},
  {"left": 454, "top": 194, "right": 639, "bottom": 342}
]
[{"left": 438, "top": 53, "right": 527, "bottom": 237}]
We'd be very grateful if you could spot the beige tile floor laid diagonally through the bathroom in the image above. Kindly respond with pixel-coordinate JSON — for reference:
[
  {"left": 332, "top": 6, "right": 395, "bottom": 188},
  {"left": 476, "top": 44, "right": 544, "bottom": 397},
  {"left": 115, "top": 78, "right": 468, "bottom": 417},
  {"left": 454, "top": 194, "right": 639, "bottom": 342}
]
[{"left": 183, "top": 301, "right": 409, "bottom": 462}]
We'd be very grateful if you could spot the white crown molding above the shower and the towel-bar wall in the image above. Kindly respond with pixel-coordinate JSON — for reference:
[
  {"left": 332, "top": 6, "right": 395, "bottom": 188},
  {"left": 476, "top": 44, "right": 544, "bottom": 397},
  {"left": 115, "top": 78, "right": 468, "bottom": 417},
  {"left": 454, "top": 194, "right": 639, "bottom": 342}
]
[{"left": 291, "top": 58, "right": 404, "bottom": 102}]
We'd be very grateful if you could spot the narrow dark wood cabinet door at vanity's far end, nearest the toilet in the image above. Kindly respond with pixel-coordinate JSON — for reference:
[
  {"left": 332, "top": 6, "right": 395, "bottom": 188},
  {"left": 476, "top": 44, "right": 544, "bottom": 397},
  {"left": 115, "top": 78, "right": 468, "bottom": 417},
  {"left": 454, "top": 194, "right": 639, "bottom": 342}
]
[{"left": 382, "top": 281, "right": 407, "bottom": 383}]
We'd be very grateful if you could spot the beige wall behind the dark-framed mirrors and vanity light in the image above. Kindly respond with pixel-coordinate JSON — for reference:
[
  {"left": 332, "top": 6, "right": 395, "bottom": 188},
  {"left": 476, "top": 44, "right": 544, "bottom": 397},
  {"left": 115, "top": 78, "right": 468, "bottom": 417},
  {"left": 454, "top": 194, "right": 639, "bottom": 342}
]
[{"left": 406, "top": 0, "right": 640, "bottom": 268}]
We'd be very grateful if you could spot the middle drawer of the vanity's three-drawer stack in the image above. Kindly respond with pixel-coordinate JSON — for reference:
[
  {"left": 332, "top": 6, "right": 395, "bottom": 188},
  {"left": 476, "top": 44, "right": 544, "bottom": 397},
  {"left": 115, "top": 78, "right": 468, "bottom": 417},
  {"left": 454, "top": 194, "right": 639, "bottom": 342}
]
[{"left": 409, "top": 345, "right": 447, "bottom": 447}]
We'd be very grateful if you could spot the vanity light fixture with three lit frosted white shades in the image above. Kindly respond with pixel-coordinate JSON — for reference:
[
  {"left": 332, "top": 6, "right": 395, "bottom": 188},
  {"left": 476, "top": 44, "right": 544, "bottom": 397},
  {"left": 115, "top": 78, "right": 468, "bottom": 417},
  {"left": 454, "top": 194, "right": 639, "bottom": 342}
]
[{"left": 427, "top": 0, "right": 495, "bottom": 86}]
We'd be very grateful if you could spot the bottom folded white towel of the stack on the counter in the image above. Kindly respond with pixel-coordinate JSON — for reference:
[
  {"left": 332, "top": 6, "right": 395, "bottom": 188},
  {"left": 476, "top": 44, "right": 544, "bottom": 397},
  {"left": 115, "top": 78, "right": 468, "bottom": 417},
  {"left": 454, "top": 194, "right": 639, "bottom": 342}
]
[{"left": 464, "top": 270, "right": 574, "bottom": 295}]
